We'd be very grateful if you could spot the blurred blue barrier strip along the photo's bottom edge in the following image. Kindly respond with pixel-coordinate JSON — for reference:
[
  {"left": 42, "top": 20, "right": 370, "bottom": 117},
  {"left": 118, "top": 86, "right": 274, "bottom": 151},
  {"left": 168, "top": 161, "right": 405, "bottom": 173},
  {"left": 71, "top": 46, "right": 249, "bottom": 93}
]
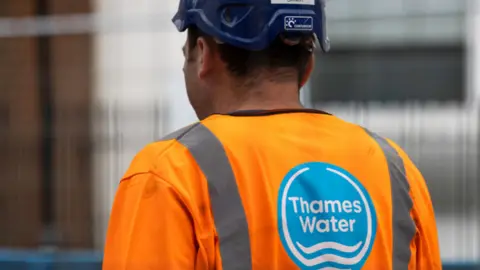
[{"left": 0, "top": 250, "right": 480, "bottom": 270}]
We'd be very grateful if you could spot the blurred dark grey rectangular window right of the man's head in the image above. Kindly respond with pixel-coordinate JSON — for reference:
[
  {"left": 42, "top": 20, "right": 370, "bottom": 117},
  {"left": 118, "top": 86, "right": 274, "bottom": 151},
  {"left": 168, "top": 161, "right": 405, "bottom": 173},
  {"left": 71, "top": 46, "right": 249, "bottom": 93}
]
[{"left": 310, "top": 44, "right": 466, "bottom": 103}]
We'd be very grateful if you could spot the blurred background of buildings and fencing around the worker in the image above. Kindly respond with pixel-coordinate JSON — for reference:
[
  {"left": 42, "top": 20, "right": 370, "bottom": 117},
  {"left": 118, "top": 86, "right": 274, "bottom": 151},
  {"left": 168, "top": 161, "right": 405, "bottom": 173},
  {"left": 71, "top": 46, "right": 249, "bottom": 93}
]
[{"left": 0, "top": 0, "right": 480, "bottom": 270}]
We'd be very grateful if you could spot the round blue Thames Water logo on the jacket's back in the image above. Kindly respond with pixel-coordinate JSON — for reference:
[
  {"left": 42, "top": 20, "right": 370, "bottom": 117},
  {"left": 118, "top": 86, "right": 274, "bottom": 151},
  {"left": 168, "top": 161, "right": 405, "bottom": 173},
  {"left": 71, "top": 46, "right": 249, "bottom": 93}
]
[{"left": 277, "top": 162, "right": 377, "bottom": 270}]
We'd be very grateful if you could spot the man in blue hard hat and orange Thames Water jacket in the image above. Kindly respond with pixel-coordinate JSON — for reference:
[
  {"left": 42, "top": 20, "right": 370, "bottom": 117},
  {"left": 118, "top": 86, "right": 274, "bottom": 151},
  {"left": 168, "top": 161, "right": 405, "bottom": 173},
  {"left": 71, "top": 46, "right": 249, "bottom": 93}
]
[{"left": 103, "top": 0, "right": 441, "bottom": 270}]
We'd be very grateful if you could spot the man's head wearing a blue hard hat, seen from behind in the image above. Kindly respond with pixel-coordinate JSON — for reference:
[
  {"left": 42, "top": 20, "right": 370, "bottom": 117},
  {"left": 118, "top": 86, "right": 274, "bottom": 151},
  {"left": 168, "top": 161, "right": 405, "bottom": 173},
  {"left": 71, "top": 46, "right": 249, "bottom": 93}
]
[{"left": 173, "top": 0, "right": 328, "bottom": 119}]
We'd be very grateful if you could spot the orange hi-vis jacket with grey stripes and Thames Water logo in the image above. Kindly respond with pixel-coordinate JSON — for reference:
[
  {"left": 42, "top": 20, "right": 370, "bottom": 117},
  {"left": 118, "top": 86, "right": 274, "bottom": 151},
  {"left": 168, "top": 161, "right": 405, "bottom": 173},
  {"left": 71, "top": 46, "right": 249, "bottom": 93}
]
[{"left": 103, "top": 109, "right": 441, "bottom": 270}]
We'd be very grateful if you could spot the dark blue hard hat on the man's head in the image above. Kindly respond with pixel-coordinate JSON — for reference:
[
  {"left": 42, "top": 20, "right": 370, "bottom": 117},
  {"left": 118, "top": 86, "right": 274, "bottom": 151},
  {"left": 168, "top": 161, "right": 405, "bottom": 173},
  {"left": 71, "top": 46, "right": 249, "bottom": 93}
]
[{"left": 172, "top": 0, "right": 330, "bottom": 52}]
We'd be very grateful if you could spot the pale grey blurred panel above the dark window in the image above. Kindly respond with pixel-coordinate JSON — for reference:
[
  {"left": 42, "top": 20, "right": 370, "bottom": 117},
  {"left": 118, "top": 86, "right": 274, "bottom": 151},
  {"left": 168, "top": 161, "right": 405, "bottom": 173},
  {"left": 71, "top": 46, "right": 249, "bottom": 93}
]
[{"left": 327, "top": 0, "right": 470, "bottom": 46}]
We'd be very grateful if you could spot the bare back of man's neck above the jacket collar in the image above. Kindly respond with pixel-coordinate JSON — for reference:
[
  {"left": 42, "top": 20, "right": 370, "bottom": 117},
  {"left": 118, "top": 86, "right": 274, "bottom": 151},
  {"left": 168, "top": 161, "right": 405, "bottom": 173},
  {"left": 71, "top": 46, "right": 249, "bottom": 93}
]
[{"left": 212, "top": 81, "right": 303, "bottom": 113}]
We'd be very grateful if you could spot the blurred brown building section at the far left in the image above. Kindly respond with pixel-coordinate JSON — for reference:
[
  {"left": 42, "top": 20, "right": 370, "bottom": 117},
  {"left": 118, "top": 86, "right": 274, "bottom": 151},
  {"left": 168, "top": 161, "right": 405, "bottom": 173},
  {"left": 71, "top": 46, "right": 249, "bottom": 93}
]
[{"left": 0, "top": 0, "right": 93, "bottom": 248}]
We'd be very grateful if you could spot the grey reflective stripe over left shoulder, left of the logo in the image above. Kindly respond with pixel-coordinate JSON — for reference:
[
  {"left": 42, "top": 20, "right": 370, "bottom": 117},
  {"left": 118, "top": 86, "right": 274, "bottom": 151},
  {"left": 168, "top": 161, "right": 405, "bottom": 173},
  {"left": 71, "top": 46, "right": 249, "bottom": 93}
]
[{"left": 177, "top": 123, "right": 252, "bottom": 270}]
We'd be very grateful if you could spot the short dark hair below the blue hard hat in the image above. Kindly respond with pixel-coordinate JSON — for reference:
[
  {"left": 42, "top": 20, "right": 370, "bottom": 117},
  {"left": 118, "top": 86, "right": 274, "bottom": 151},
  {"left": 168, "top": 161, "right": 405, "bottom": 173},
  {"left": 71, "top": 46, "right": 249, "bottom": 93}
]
[{"left": 188, "top": 26, "right": 312, "bottom": 84}]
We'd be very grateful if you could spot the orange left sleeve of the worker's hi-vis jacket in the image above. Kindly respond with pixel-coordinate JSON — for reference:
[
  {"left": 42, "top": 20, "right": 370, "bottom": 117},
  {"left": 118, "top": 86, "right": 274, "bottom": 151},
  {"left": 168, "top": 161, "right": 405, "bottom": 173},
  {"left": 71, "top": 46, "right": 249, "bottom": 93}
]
[{"left": 103, "top": 173, "right": 197, "bottom": 270}]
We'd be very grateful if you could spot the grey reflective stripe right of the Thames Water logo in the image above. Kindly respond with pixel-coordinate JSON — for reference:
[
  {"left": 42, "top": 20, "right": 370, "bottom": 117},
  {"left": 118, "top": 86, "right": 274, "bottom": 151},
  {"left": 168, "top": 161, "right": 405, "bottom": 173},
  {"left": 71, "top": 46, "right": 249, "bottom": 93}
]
[{"left": 366, "top": 130, "right": 416, "bottom": 270}]
